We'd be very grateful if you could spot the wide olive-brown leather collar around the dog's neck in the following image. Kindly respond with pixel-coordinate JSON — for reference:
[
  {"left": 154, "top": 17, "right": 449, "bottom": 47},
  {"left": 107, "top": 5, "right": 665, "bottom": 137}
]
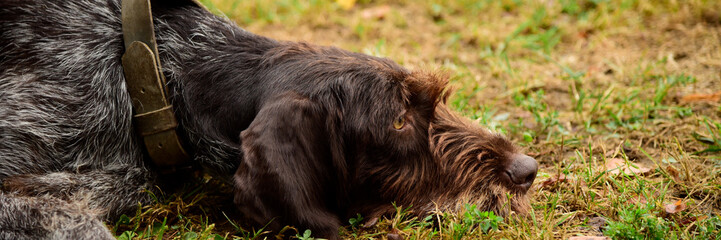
[{"left": 121, "top": 0, "right": 190, "bottom": 169}]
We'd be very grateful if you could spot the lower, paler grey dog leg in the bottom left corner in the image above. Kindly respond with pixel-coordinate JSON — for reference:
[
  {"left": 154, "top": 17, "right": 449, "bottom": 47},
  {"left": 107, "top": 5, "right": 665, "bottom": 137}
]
[{"left": 0, "top": 193, "right": 115, "bottom": 240}]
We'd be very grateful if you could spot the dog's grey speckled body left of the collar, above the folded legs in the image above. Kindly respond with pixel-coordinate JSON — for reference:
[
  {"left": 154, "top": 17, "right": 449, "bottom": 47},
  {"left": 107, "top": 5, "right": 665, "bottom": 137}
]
[{"left": 0, "top": 0, "right": 146, "bottom": 178}]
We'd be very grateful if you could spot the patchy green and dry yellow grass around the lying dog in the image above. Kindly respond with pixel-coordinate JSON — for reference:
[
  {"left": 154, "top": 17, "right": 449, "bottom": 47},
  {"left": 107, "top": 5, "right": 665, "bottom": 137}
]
[{"left": 114, "top": 0, "right": 721, "bottom": 239}]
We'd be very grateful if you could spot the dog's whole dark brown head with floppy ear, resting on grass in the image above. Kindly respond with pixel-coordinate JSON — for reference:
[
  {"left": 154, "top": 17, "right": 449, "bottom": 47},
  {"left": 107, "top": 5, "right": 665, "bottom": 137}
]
[{"left": 235, "top": 44, "right": 537, "bottom": 236}]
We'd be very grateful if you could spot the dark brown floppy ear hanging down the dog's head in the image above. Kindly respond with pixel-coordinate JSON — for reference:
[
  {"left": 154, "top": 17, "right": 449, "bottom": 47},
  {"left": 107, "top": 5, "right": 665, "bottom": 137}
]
[{"left": 234, "top": 93, "right": 340, "bottom": 238}]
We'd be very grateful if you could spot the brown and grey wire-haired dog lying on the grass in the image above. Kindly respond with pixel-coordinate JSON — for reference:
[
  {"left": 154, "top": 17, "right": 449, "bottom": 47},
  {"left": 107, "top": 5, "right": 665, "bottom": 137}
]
[{"left": 0, "top": 0, "right": 538, "bottom": 239}]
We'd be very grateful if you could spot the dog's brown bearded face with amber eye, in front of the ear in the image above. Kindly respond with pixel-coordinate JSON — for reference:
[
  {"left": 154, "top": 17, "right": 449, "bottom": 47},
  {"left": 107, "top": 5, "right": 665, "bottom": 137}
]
[{"left": 334, "top": 63, "right": 537, "bottom": 218}]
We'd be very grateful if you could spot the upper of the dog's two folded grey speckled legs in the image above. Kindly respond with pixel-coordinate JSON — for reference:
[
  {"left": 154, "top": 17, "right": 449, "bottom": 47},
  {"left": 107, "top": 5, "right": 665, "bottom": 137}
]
[{"left": 3, "top": 167, "right": 154, "bottom": 219}]
